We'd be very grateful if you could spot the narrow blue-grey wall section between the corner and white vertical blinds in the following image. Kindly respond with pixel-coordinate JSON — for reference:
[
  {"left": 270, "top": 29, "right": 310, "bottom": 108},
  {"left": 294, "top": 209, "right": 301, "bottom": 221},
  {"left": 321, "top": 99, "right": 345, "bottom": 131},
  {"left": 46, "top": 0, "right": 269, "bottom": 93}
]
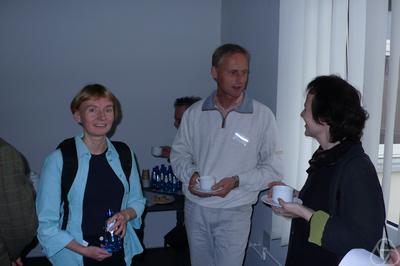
[{"left": 221, "top": 0, "right": 279, "bottom": 112}]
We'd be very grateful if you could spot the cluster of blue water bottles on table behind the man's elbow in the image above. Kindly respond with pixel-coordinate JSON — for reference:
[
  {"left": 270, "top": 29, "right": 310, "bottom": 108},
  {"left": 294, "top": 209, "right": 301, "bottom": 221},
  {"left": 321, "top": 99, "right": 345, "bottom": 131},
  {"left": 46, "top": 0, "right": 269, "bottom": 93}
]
[{"left": 150, "top": 164, "right": 182, "bottom": 192}]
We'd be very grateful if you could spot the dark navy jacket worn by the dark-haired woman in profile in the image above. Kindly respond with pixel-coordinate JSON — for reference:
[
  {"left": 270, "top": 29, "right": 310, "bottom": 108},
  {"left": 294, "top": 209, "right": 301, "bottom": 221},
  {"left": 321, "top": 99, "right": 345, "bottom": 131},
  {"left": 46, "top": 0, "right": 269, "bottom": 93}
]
[{"left": 286, "top": 142, "right": 385, "bottom": 266}]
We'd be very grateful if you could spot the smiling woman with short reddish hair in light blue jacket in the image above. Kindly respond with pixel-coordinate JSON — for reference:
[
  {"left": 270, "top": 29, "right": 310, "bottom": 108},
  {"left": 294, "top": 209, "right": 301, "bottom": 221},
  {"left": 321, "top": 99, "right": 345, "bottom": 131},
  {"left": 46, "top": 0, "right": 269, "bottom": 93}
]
[{"left": 37, "top": 84, "right": 145, "bottom": 266}]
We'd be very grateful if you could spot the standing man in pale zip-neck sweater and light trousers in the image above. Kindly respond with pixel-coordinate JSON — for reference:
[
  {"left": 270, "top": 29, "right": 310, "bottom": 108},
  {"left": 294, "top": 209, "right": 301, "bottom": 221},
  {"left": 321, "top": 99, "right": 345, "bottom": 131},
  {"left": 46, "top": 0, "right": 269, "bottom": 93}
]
[{"left": 171, "top": 44, "right": 281, "bottom": 266}]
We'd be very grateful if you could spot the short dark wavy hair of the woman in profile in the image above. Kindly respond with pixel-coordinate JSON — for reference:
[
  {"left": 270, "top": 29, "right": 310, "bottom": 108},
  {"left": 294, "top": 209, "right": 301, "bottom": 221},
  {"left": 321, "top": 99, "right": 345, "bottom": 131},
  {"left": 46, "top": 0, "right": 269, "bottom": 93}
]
[{"left": 306, "top": 75, "right": 368, "bottom": 142}]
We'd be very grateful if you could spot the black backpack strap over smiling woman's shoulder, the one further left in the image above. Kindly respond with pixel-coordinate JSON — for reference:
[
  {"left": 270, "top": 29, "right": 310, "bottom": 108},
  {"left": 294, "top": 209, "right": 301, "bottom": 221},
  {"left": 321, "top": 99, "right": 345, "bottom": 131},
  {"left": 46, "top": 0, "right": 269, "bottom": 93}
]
[{"left": 57, "top": 138, "right": 78, "bottom": 230}]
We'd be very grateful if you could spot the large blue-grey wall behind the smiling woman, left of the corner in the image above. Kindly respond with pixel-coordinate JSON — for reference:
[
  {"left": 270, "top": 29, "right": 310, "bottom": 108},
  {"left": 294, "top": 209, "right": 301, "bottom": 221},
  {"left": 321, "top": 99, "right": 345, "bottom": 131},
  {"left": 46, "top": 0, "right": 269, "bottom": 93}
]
[{"left": 0, "top": 0, "right": 221, "bottom": 172}]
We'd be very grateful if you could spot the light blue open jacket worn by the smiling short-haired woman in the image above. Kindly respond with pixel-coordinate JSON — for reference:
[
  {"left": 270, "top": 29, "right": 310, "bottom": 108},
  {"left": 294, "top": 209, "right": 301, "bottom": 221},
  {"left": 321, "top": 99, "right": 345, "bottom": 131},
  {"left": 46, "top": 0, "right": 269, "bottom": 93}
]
[{"left": 36, "top": 136, "right": 146, "bottom": 266}]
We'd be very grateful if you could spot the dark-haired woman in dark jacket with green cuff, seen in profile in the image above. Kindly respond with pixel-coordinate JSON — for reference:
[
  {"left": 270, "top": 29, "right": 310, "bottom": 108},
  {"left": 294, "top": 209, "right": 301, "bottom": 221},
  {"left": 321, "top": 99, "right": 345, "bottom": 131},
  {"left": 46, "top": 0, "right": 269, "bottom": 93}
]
[{"left": 270, "top": 76, "right": 385, "bottom": 266}]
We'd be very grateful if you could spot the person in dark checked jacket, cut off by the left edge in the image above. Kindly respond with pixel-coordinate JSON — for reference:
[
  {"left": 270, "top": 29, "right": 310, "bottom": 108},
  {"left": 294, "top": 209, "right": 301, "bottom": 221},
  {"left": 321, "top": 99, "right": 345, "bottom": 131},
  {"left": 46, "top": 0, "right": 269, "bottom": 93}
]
[{"left": 0, "top": 138, "right": 37, "bottom": 266}]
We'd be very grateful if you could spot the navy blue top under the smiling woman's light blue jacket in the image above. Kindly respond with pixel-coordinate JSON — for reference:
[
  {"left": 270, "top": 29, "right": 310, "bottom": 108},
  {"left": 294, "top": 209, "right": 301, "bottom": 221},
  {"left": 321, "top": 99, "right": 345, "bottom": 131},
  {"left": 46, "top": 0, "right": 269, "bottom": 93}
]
[{"left": 82, "top": 151, "right": 124, "bottom": 241}]
